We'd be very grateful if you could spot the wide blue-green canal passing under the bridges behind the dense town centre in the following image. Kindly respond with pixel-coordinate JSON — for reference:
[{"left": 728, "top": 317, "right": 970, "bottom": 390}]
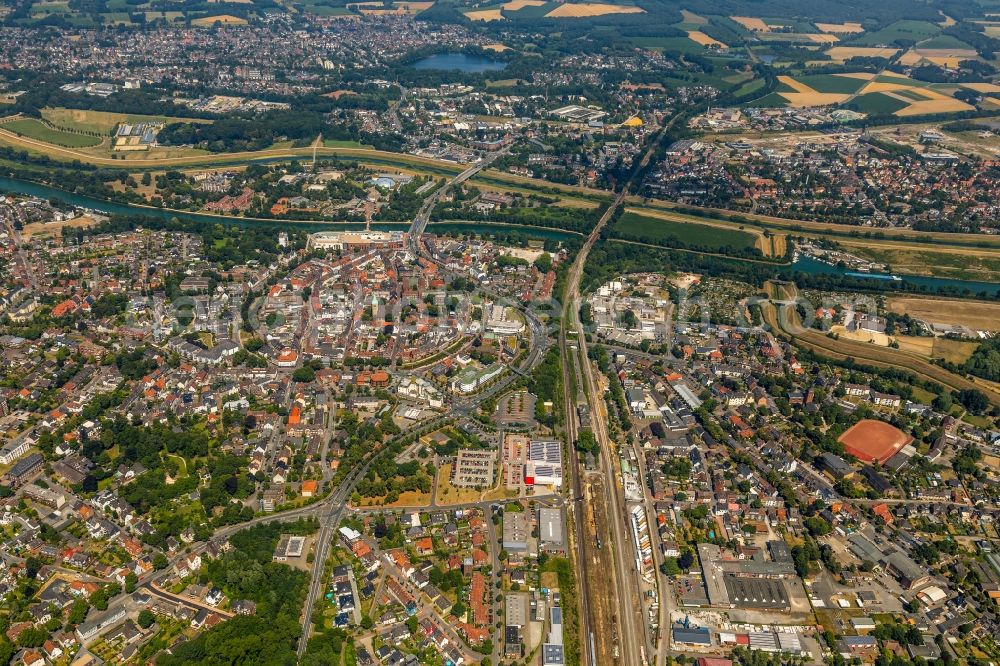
[{"left": 0, "top": 178, "right": 1000, "bottom": 295}]
